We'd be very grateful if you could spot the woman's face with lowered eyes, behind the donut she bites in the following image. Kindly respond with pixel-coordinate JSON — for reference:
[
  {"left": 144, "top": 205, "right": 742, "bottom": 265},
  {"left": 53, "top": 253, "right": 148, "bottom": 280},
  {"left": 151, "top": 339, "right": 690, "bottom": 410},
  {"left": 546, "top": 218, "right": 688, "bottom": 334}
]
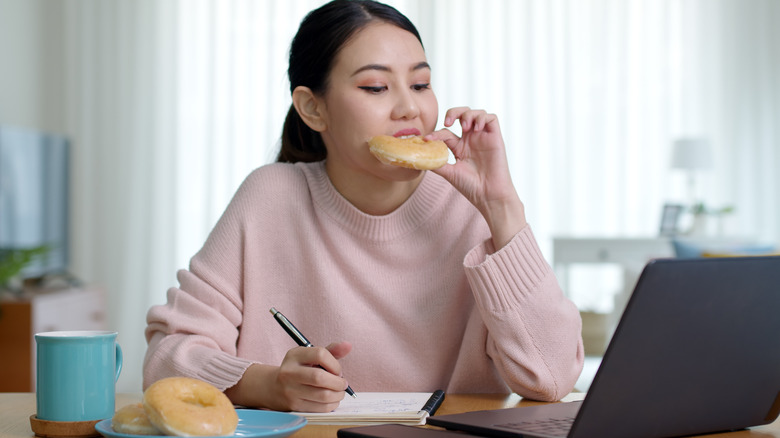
[{"left": 321, "top": 22, "right": 438, "bottom": 181}]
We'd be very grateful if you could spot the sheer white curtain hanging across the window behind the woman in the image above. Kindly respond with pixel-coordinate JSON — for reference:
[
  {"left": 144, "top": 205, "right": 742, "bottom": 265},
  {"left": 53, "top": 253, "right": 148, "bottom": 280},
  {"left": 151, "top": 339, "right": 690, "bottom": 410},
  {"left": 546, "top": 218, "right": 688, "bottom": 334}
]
[{"left": 61, "top": 0, "right": 780, "bottom": 391}]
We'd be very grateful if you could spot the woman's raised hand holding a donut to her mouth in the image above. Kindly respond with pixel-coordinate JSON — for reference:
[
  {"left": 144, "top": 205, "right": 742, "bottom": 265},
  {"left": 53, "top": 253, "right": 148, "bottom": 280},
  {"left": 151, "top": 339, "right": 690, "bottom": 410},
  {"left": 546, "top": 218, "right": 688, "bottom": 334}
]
[{"left": 426, "top": 107, "right": 526, "bottom": 249}]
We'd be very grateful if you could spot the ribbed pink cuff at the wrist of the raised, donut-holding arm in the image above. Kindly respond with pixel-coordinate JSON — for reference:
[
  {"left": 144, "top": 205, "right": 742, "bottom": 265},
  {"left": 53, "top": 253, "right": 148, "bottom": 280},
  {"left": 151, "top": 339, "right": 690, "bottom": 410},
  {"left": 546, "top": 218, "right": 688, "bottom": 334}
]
[{"left": 464, "top": 225, "right": 554, "bottom": 311}]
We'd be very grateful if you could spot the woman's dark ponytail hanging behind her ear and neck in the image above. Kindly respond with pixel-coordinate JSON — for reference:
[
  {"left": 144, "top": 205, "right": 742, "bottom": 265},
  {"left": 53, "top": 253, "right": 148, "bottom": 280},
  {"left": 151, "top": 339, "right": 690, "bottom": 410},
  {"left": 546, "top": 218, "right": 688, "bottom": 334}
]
[{"left": 276, "top": 105, "right": 328, "bottom": 163}]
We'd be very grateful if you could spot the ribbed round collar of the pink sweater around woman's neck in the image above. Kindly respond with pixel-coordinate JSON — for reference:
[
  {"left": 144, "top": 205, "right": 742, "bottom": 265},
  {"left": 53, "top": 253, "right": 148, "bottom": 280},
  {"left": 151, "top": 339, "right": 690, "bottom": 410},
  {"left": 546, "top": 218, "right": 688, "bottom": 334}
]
[{"left": 296, "top": 161, "right": 451, "bottom": 241}]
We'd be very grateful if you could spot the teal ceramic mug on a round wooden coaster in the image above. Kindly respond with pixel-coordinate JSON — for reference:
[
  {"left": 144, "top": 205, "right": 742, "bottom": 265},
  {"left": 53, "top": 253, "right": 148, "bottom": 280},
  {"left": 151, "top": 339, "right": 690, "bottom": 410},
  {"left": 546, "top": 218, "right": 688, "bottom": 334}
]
[{"left": 35, "top": 331, "right": 122, "bottom": 421}]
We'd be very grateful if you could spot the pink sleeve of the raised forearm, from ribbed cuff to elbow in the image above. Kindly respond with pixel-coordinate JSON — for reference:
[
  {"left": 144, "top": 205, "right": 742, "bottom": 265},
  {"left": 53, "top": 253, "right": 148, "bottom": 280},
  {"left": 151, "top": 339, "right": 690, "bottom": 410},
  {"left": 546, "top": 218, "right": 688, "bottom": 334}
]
[{"left": 464, "top": 226, "right": 584, "bottom": 401}]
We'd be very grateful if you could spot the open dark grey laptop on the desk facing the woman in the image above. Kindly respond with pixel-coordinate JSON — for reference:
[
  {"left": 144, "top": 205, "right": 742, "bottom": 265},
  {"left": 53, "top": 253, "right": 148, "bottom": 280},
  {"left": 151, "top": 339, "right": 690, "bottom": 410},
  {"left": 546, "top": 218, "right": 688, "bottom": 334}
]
[{"left": 427, "top": 256, "right": 780, "bottom": 438}]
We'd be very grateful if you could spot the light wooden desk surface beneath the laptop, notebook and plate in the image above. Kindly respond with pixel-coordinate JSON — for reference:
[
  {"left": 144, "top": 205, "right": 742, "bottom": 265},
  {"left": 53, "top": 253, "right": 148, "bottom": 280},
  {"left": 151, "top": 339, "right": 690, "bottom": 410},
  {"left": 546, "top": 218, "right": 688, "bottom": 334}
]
[{"left": 0, "top": 392, "right": 780, "bottom": 438}]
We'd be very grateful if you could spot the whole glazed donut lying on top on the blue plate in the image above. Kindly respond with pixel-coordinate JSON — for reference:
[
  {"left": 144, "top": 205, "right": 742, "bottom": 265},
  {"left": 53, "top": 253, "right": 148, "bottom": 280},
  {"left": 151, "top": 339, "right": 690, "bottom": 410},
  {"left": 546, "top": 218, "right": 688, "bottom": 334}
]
[{"left": 143, "top": 377, "right": 238, "bottom": 436}]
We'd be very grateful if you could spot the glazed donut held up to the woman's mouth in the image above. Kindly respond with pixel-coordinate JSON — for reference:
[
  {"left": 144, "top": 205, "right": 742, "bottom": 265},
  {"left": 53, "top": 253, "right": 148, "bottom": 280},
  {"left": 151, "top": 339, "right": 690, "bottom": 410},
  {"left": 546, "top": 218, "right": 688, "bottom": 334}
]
[{"left": 368, "top": 135, "right": 450, "bottom": 170}]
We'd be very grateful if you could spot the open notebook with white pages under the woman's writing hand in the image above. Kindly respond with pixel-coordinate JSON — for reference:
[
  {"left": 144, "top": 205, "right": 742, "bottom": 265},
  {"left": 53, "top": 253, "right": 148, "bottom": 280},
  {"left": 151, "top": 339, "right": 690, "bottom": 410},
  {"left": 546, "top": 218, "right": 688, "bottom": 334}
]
[{"left": 295, "top": 391, "right": 444, "bottom": 425}]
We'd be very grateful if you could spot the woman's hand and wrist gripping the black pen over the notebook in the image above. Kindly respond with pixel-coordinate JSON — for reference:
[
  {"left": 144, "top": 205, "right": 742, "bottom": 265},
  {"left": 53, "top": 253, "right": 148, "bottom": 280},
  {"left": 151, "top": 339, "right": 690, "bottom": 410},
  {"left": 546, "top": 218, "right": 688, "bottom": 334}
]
[{"left": 225, "top": 342, "right": 352, "bottom": 412}]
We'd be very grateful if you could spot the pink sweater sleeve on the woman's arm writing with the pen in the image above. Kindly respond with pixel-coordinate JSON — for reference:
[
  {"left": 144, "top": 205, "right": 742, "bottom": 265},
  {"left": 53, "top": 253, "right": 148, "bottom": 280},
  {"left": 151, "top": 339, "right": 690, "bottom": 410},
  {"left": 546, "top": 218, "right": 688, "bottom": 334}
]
[{"left": 143, "top": 169, "right": 268, "bottom": 390}]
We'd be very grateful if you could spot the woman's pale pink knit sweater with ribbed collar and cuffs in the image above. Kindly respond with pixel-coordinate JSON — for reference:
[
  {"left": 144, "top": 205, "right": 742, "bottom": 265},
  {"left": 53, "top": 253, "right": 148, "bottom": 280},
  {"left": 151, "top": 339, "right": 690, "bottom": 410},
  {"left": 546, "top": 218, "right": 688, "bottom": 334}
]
[{"left": 144, "top": 163, "right": 583, "bottom": 400}]
